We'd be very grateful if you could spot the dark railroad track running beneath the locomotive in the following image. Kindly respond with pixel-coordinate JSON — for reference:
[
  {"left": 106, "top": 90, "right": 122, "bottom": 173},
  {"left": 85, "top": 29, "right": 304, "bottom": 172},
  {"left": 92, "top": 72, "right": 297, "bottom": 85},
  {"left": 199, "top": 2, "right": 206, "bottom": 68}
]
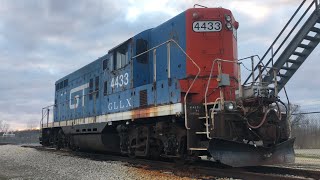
[{"left": 23, "top": 146, "right": 320, "bottom": 180}]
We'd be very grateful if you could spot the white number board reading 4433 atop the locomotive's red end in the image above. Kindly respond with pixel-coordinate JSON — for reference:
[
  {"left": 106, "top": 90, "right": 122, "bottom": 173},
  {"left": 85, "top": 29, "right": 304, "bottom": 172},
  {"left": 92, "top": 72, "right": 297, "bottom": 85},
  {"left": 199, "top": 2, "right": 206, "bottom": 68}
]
[{"left": 192, "top": 21, "right": 222, "bottom": 32}]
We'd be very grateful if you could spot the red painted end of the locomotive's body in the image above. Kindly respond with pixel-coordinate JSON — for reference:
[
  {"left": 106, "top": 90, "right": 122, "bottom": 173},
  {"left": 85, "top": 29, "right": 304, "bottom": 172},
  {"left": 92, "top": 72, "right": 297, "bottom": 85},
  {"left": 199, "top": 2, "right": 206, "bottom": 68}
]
[{"left": 180, "top": 8, "right": 238, "bottom": 103}]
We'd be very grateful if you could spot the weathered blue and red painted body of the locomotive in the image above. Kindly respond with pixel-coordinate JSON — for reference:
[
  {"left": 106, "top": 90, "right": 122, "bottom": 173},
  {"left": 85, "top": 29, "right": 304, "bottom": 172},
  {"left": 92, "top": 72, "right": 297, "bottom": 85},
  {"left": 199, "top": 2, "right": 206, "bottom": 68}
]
[{"left": 47, "top": 8, "right": 238, "bottom": 126}]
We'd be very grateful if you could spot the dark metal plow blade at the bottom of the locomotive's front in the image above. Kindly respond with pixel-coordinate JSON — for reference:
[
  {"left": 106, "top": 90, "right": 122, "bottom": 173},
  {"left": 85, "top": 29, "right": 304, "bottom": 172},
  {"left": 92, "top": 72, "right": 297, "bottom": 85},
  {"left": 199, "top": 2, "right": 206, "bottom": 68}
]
[{"left": 208, "top": 138, "right": 295, "bottom": 167}]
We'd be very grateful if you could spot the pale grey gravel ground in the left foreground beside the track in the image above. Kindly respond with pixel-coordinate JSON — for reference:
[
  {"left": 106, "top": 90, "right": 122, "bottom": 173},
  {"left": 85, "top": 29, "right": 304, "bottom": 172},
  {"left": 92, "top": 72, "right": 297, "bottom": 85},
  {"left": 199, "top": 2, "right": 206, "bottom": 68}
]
[{"left": 0, "top": 145, "right": 195, "bottom": 180}]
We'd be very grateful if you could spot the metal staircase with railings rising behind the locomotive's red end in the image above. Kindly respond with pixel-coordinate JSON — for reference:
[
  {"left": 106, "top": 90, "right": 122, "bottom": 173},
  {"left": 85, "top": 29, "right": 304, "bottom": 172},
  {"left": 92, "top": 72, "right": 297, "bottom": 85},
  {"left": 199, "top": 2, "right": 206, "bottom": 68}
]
[{"left": 244, "top": 0, "right": 320, "bottom": 95}]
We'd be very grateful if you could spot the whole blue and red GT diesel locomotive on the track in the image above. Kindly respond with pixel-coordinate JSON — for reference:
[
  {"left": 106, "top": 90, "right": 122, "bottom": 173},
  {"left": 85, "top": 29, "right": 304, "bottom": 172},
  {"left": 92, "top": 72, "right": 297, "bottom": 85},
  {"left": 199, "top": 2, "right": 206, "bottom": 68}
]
[{"left": 40, "top": 8, "right": 294, "bottom": 166}]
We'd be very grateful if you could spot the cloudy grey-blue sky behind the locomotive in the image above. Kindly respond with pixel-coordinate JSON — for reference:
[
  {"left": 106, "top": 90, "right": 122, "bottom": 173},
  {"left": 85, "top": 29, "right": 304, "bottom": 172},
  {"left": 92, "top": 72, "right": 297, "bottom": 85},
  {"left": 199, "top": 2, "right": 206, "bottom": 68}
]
[{"left": 0, "top": 0, "right": 320, "bottom": 129}]
